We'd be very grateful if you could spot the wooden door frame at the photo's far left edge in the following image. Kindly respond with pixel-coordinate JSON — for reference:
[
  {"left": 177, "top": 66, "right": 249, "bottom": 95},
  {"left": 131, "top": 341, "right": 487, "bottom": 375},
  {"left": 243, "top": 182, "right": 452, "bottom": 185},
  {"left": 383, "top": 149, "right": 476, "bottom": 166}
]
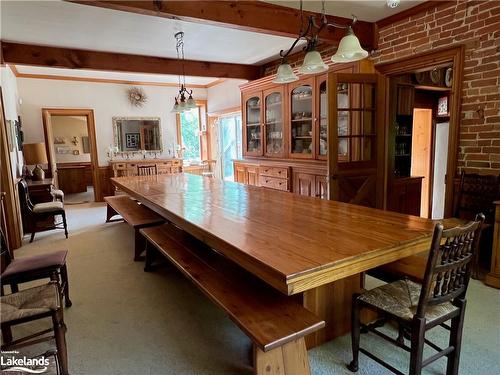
[{"left": 0, "top": 90, "right": 23, "bottom": 250}]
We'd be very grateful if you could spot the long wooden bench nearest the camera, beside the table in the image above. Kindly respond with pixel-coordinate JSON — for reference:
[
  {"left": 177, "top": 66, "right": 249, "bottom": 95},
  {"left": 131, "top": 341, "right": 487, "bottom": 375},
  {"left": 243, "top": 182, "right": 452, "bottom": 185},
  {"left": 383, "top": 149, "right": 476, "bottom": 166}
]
[{"left": 140, "top": 224, "right": 325, "bottom": 375}]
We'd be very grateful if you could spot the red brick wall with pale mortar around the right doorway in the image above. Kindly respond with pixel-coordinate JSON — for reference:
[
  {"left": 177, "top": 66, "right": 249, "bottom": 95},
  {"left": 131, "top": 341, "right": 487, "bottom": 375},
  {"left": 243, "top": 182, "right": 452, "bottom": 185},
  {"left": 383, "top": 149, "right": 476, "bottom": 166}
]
[{"left": 265, "top": 0, "right": 500, "bottom": 174}]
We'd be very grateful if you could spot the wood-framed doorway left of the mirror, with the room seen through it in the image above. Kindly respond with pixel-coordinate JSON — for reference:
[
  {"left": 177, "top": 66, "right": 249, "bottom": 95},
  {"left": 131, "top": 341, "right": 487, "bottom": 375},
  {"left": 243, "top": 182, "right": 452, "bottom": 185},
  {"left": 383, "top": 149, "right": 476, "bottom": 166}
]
[{"left": 42, "top": 109, "right": 100, "bottom": 204}]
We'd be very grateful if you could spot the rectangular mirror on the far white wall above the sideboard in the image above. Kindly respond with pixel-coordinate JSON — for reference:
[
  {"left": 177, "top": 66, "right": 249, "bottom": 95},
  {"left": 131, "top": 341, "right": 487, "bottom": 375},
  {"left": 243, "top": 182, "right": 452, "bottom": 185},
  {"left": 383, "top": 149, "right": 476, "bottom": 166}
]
[{"left": 113, "top": 117, "right": 163, "bottom": 152}]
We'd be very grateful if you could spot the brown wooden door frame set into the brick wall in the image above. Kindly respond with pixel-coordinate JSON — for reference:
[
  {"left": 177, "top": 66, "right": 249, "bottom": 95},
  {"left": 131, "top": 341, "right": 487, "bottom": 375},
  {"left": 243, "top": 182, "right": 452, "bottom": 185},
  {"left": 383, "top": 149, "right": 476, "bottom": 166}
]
[{"left": 375, "top": 45, "right": 465, "bottom": 217}]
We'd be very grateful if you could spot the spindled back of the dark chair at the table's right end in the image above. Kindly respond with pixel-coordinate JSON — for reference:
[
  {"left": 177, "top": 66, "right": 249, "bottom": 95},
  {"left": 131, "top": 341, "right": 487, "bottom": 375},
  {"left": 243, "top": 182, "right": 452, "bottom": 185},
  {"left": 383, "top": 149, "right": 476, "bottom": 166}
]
[{"left": 417, "top": 214, "right": 484, "bottom": 317}]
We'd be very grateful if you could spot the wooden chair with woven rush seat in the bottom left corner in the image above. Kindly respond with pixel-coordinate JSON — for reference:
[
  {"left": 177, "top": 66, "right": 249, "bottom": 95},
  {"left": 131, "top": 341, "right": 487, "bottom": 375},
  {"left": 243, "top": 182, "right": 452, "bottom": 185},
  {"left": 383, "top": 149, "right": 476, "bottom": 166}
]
[{"left": 0, "top": 282, "right": 68, "bottom": 375}]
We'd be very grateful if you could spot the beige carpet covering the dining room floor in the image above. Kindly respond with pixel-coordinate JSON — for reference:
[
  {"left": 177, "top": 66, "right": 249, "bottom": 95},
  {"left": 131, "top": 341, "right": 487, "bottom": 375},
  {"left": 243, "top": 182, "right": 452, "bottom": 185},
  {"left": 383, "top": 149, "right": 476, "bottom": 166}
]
[{"left": 10, "top": 203, "right": 500, "bottom": 375}]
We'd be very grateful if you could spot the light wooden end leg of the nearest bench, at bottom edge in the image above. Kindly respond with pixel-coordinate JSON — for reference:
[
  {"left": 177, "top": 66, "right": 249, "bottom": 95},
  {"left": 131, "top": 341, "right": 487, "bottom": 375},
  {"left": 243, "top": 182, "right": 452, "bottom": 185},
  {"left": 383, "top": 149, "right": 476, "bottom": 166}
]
[{"left": 254, "top": 337, "right": 311, "bottom": 375}]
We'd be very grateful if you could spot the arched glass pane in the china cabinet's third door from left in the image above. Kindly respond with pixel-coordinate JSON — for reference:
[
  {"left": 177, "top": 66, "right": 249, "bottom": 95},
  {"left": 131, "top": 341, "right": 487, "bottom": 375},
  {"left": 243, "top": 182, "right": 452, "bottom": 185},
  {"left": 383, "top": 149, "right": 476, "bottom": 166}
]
[{"left": 290, "top": 84, "right": 314, "bottom": 158}]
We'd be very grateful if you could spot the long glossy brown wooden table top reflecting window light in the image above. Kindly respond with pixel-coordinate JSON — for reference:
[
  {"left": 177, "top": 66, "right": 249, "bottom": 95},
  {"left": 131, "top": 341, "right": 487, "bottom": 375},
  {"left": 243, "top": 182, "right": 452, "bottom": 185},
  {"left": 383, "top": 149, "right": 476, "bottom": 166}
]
[{"left": 111, "top": 174, "right": 434, "bottom": 295}]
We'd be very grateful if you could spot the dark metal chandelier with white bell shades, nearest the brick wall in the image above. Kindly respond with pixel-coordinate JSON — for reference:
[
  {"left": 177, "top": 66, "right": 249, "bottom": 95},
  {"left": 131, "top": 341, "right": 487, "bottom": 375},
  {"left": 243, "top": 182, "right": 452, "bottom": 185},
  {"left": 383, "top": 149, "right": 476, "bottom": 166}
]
[{"left": 273, "top": 0, "right": 368, "bottom": 83}]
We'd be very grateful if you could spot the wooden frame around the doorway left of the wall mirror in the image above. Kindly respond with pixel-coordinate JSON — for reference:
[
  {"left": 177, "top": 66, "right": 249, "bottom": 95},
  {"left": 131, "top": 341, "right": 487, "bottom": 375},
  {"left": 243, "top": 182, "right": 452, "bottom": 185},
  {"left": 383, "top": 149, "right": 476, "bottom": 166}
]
[{"left": 42, "top": 108, "right": 102, "bottom": 202}]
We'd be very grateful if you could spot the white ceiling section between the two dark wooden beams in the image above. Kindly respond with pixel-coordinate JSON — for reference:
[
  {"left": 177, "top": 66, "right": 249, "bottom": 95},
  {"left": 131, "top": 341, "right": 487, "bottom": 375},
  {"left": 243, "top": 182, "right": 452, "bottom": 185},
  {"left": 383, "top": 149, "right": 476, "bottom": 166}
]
[{"left": 0, "top": 0, "right": 304, "bottom": 64}]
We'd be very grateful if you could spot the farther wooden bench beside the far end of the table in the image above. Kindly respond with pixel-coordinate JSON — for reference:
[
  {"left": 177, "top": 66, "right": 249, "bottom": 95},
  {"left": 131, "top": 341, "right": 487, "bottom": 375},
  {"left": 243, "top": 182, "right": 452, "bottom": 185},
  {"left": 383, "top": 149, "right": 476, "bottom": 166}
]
[{"left": 104, "top": 195, "right": 165, "bottom": 261}]
